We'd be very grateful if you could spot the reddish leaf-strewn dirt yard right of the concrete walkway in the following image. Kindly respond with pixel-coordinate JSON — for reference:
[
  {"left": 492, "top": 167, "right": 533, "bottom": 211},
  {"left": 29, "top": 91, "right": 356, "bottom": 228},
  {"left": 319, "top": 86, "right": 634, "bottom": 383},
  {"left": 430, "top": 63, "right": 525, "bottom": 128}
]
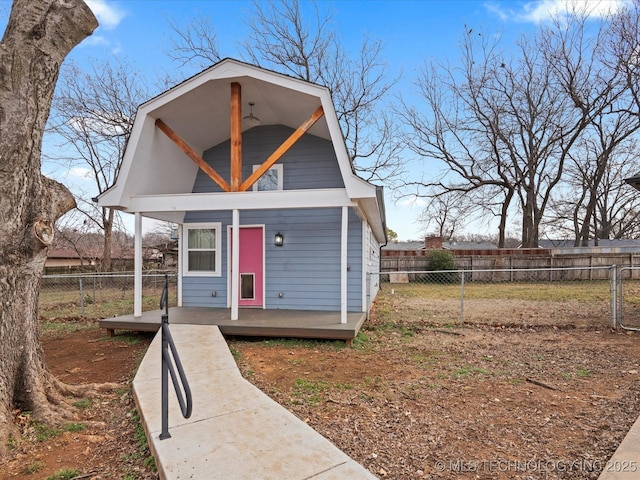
[{"left": 232, "top": 324, "right": 640, "bottom": 479}]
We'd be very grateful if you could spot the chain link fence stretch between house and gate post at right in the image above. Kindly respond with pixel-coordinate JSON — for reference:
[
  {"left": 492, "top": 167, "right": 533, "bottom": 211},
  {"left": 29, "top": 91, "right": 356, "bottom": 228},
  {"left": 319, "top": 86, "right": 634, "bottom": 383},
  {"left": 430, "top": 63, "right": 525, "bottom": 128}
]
[{"left": 370, "top": 266, "right": 616, "bottom": 327}]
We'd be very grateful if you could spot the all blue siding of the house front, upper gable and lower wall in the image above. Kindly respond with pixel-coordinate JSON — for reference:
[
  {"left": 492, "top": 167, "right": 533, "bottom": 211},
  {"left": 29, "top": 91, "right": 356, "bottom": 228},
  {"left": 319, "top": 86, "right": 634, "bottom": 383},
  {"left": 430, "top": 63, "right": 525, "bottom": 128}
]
[{"left": 182, "top": 125, "right": 363, "bottom": 312}]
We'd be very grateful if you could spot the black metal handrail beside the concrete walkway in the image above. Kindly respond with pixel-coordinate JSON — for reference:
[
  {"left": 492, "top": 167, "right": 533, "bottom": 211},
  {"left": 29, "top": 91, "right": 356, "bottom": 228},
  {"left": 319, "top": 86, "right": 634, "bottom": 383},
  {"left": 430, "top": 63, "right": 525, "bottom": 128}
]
[{"left": 159, "top": 275, "right": 193, "bottom": 440}]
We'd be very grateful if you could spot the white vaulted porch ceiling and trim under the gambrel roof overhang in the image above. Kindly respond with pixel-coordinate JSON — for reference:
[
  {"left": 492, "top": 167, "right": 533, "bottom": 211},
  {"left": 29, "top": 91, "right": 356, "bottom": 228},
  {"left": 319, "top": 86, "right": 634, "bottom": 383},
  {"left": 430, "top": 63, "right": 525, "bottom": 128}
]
[{"left": 99, "top": 60, "right": 342, "bottom": 210}]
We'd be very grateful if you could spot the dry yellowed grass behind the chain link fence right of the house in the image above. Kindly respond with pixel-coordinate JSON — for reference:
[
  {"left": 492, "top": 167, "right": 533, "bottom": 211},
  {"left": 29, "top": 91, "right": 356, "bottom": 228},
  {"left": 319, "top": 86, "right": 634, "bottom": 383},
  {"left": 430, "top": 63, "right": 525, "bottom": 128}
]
[{"left": 376, "top": 281, "right": 611, "bottom": 329}]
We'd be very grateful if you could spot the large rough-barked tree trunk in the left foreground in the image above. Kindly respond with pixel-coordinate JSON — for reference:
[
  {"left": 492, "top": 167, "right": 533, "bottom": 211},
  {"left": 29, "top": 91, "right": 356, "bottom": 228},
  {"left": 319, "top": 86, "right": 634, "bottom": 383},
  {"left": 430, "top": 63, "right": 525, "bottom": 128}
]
[{"left": 0, "top": 0, "right": 97, "bottom": 454}]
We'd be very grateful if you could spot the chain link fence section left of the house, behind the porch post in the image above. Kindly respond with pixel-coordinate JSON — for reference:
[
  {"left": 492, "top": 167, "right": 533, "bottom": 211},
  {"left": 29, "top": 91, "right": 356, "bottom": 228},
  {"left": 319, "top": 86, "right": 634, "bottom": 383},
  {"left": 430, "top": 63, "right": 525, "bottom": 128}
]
[{"left": 38, "top": 270, "right": 177, "bottom": 320}]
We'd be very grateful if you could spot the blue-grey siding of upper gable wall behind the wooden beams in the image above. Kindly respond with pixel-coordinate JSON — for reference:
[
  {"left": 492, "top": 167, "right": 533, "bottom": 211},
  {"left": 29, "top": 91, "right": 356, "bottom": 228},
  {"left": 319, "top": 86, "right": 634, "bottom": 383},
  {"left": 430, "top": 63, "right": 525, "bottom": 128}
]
[{"left": 193, "top": 125, "right": 344, "bottom": 193}]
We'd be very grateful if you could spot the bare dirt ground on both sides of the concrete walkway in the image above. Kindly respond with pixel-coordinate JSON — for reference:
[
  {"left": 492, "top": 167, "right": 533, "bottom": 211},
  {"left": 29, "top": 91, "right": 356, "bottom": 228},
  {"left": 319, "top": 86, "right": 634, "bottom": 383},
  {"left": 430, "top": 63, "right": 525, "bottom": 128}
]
[{"left": 0, "top": 314, "right": 640, "bottom": 479}]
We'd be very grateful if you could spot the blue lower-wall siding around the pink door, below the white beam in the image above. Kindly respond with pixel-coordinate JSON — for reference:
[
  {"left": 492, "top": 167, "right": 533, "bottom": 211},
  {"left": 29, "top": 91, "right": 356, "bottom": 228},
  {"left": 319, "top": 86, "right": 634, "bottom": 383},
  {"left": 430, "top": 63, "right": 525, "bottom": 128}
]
[{"left": 182, "top": 208, "right": 362, "bottom": 311}]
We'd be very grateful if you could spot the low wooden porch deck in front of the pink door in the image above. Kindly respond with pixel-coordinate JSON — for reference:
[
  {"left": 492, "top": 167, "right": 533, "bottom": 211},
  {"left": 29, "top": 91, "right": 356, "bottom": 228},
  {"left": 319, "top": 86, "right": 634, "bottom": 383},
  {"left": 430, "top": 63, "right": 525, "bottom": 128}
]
[{"left": 99, "top": 307, "right": 367, "bottom": 342}]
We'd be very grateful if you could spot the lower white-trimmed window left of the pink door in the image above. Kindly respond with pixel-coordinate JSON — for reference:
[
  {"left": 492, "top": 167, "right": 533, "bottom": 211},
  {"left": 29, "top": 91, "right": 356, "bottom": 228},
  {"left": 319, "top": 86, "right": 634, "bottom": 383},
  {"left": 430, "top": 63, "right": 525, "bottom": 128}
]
[{"left": 182, "top": 223, "right": 222, "bottom": 276}]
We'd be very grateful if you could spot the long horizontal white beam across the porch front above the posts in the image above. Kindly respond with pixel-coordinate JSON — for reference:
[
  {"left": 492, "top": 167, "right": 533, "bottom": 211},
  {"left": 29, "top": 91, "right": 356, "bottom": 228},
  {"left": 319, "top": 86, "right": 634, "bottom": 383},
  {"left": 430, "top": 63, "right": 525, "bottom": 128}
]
[{"left": 125, "top": 188, "right": 356, "bottom": 212}]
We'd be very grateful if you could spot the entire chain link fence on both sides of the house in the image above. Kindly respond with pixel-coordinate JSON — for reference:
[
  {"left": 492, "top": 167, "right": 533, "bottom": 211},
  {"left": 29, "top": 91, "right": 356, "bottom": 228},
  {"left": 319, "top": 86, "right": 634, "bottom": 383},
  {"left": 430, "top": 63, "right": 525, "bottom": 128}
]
[{"left": 39, "top": 266, "right": 624, "bottom": 329}]
